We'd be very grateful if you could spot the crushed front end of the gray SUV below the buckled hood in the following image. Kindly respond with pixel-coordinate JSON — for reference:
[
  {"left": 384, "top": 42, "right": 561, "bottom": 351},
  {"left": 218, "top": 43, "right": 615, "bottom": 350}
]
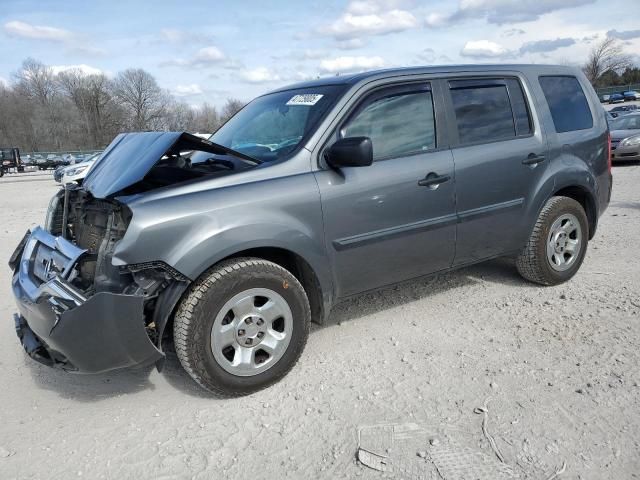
[{"left": 10, "top": 183, "right": 188, "bottom": 373}]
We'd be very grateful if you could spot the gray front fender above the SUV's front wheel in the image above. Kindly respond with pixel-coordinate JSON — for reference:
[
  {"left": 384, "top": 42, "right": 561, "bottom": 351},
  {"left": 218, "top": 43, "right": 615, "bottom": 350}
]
[{"left": 113, "top": 173, "right": 333, "bottom": 312}]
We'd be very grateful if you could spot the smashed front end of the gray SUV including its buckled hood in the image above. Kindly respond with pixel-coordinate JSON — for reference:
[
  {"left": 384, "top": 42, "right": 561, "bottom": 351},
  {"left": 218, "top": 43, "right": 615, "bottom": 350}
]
[{"left": 9, "top": 132, "right": 261, "bottom": 373}]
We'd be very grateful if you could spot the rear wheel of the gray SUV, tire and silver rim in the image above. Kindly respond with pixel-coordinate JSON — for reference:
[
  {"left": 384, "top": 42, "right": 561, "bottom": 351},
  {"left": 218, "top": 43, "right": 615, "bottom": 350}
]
[{"left": 516, "top": 197, "right": 589, "bottom": 285}]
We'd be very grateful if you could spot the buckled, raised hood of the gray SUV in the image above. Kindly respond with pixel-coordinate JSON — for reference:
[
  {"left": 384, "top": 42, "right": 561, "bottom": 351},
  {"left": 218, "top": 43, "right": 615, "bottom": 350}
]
[{"left": 82, "top": 132, "right": 259, "bottom": 198}]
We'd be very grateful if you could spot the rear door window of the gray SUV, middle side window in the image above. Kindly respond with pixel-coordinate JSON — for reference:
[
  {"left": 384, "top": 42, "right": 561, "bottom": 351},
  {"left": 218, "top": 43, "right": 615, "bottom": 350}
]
[{"left": 449, "top": 78, "right": 532, "bottom": 144}]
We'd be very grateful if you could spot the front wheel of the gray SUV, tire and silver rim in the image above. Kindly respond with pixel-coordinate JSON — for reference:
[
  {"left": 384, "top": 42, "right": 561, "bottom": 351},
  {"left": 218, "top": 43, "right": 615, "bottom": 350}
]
[{"left": 173, "top": 258, "right": 311, "bottom": 396}]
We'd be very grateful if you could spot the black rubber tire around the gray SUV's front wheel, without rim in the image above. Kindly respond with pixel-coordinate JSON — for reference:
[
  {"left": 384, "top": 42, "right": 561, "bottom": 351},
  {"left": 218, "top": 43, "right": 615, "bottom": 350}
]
[{"left": 173, "top": 258, "right": 311, "bottom": 397}]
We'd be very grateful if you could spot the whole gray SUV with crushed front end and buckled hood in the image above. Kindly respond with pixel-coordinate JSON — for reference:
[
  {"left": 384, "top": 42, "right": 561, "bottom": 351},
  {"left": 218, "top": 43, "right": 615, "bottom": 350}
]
[{"left": 10, "top": 65, "right": 612, "bottom": 395}]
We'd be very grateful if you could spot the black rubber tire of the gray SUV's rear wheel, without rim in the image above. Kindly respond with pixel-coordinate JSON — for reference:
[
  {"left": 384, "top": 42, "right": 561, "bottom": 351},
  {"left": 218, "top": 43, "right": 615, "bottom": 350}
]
[{"left": 516, "top": 197, "right": 589, "bottom": 285}]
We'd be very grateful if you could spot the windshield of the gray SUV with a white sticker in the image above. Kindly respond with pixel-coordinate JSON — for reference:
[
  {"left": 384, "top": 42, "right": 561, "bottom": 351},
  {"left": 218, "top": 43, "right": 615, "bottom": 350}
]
[{"left": 204, "top": 85, "right": 345, "bottom": 162}]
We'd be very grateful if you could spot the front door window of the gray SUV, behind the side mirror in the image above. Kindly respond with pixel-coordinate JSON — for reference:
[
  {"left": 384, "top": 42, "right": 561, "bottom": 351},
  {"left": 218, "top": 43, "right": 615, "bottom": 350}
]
[{"left": 340, "top": 86, "right": 436, "bottom": 161}]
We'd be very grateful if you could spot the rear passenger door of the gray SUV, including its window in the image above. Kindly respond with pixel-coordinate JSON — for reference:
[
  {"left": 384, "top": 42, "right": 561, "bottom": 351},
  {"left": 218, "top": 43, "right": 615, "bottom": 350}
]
[{"left": 444, "top": 76, "right": 548, "bottom": 265}]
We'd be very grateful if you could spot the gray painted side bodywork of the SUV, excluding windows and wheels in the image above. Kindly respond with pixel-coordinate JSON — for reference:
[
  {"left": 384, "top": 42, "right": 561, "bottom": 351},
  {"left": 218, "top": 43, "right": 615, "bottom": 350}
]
[{"left": 114, "top": 65, "right": 609, "bottom": 316}]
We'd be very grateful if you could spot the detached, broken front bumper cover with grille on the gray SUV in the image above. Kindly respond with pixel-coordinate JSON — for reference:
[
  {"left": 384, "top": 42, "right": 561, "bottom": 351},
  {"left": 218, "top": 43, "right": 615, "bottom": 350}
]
[{"left": 12, "top": 227, "right": 164, "bottom": 373}]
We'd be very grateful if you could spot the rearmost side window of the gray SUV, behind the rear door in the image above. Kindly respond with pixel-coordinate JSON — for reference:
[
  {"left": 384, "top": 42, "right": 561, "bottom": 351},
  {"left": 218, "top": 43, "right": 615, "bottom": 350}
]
[{"left": 539, "top": 76, "right": 593, "bottom": 133}]
